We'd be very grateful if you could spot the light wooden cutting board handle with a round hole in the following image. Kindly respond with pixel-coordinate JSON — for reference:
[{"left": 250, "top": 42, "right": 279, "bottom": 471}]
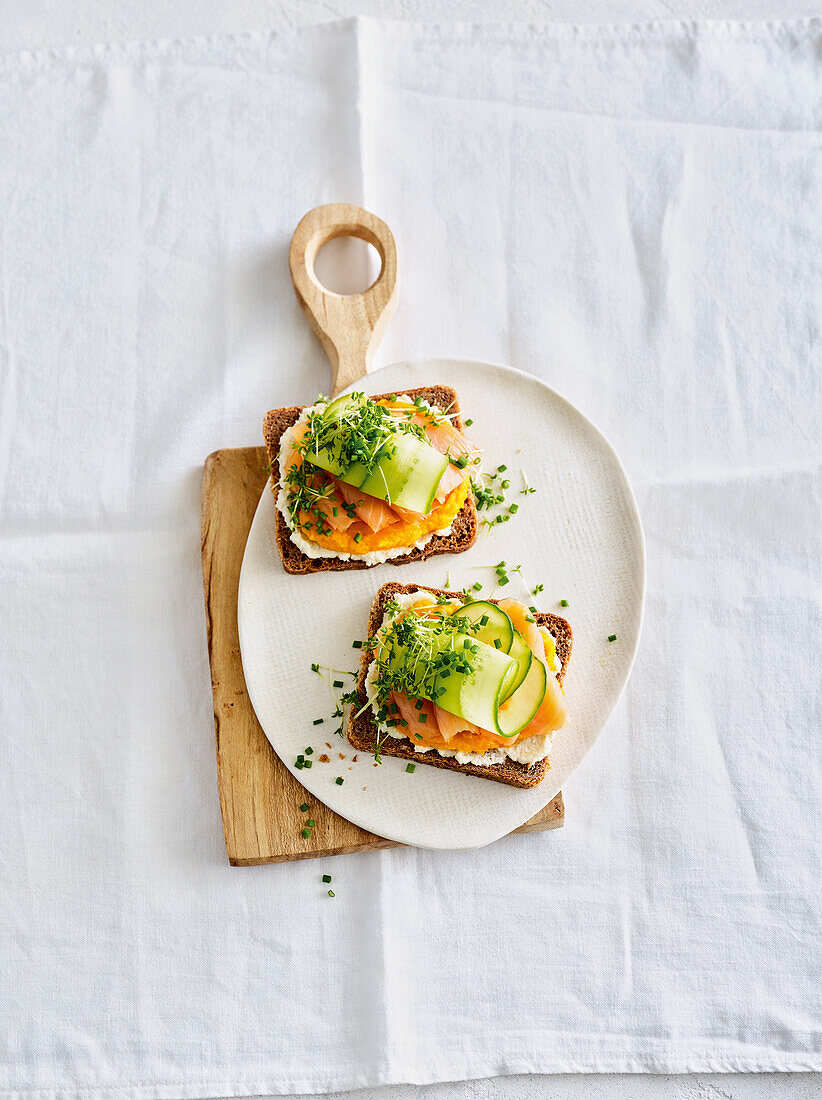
[{"left": 288, "top": 202, "right": 397, "bottom": 396}]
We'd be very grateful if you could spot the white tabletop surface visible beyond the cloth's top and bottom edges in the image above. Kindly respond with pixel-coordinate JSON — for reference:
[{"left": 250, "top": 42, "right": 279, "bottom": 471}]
[{"left": 0, "top": 0, "right": 822, "bottom": 1100}]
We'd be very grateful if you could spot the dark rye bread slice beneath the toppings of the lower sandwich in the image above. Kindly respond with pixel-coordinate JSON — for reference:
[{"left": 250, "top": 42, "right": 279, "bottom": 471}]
[{"left": 348, "top": 581, "right": 573, "bottom": 788}]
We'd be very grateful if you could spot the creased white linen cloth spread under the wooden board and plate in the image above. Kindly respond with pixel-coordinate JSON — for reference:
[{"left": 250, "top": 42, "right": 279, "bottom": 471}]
[{"left": 0, "top": 21, "right": 822, "bottom": 1098}]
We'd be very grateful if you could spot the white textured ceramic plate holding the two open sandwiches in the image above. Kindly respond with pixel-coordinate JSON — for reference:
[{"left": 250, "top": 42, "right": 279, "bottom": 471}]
[{"left": 239, "top": 360, "right": 645, "bottom": 848}]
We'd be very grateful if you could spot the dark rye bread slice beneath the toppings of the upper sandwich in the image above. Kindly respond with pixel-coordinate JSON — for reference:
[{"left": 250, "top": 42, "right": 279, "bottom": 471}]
[{"left": 263, "top": 386, "right": 479, "bottom": 573}]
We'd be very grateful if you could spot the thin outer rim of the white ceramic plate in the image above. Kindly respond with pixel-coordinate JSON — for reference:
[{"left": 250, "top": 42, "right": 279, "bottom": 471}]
[{"left": 237, "top": 356, "right": 647, "bottom": 851}]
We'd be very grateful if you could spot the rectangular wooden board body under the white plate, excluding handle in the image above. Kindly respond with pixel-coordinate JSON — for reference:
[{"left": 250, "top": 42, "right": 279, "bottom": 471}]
[{"left": 201, "top": 447, "right": 565, "bottom": 867}]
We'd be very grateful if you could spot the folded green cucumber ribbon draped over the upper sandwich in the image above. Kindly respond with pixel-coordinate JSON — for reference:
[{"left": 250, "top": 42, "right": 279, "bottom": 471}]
[{"left": 305, "top": 394, "right": 448, "bottom": 514}]
